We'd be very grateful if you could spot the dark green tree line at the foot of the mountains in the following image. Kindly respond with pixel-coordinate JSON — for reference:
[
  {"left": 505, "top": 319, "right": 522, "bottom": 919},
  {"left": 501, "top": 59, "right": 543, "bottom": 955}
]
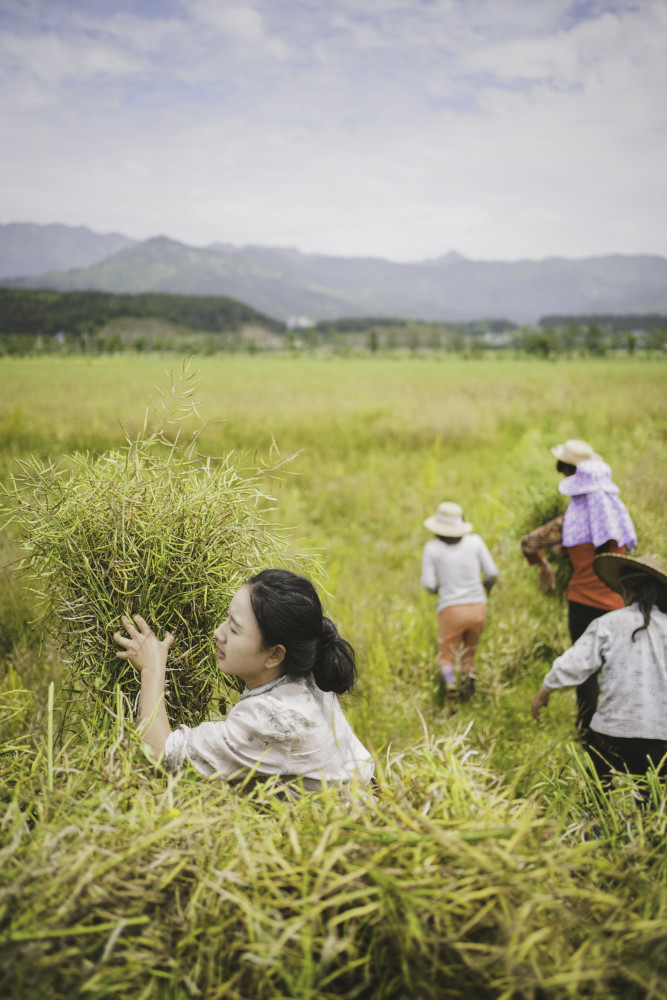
[{"left": 0, "top": 287, "right": 667, "bottom": 358}]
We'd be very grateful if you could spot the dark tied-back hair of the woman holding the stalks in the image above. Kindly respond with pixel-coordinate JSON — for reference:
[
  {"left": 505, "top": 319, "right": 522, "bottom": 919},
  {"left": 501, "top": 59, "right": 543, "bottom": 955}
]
[{"left": 248, "top": 569, "right": 357, "bottom": 694}]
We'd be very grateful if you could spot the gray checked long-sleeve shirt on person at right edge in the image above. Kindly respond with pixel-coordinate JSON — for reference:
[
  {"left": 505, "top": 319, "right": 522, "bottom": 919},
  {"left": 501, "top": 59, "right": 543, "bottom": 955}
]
[{"left": 544, "top": 604, "right": 667, "bottom": 740}]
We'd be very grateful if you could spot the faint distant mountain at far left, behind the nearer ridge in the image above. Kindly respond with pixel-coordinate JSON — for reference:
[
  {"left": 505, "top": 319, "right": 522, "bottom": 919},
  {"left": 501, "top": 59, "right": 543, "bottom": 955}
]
[{"left": 0, "top": 222, "right": 136, "bottom": 278}]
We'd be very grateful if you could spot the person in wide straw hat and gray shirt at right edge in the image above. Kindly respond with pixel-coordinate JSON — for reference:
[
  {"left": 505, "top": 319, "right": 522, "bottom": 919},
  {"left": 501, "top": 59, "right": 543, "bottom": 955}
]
[{"left": 531, "top": 553, "right": 667, "bottom": 788}]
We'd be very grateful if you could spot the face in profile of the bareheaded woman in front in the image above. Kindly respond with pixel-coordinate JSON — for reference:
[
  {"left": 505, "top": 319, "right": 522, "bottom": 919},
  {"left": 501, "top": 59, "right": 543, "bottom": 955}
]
[{"left": 213, "top": 587, "right": 285, "bottom": 688}]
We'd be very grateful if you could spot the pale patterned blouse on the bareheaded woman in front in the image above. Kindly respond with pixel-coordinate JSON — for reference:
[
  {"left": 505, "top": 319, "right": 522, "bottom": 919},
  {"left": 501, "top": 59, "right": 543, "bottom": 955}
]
[{"left": 165, "top": 676, "right": 374, "bottom": 790}]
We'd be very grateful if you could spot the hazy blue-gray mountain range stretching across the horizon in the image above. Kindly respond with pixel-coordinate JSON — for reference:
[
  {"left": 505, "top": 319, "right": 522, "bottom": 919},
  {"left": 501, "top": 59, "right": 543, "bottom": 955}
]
[{"left": 0, "top": 223, "right": 667, "bottom": 323}]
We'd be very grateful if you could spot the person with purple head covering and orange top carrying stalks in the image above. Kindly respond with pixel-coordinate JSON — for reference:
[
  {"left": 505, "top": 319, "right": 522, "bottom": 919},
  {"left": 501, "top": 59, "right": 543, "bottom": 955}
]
[{"left": 521, "top": 440, "right": 637, "bottom": 743}]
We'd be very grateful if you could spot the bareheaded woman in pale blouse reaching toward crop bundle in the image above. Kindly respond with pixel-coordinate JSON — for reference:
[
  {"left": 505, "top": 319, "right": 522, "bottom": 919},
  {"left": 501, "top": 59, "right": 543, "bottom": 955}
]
[{"left": 114, "top": 569, "right": 373, "bottom": 791}]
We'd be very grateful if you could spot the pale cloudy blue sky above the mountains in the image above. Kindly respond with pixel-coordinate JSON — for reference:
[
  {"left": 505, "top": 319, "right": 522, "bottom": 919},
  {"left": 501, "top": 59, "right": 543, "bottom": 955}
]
[{"left": 0, "top": 0, "right": 667, "bottom": 261}]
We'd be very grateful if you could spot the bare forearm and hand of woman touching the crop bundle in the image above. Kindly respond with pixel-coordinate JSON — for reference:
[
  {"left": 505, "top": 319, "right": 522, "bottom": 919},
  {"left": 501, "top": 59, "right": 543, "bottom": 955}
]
[{"left": 114, "top": 615, "right": 174, "bottom": 753}]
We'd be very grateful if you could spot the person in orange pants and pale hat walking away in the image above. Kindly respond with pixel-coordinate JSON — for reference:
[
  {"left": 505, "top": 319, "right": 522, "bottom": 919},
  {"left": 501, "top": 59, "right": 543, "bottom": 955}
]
[{"left": 421, "top": 501, "right": 498, "bottom": 701}]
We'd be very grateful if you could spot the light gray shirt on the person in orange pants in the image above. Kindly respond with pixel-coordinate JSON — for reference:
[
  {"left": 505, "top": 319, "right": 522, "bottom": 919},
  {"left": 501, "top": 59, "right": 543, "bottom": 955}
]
[{"left": 421, "top": 534, "right": 498, "bottom": 611}]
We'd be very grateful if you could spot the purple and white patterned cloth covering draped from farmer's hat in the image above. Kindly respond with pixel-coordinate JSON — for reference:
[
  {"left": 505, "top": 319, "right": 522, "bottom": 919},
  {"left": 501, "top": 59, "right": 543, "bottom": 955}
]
[{"left": 558, "top": 459, "right": 637, "bottom": 552}]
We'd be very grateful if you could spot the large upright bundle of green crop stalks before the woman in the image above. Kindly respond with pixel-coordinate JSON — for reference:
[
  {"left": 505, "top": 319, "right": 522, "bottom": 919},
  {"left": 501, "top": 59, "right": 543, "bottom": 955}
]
[{"left": 1, "top": 368, "right": 290, "bottom": 727}]
